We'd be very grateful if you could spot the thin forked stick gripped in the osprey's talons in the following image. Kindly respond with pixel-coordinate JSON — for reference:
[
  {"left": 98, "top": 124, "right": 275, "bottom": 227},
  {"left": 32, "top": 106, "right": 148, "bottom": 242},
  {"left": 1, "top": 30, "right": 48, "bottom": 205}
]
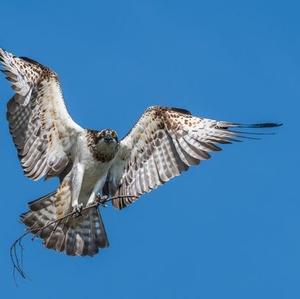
[{"left": 10, "top": 195, "right": 137, "bottom": 285}]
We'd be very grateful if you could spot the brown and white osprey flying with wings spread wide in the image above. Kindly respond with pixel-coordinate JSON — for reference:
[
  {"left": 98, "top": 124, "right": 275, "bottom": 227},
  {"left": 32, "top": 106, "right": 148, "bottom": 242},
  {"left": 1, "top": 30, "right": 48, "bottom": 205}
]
[{"left": 0, "top": 49, "right": 278, "bottom": 256}]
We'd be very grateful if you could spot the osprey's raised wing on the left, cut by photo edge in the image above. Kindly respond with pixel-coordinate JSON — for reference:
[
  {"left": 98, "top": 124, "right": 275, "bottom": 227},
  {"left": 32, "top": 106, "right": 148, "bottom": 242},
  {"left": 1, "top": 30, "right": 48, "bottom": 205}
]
[{"left": 0, "top": 48, "right": 83, "bottom": 180}]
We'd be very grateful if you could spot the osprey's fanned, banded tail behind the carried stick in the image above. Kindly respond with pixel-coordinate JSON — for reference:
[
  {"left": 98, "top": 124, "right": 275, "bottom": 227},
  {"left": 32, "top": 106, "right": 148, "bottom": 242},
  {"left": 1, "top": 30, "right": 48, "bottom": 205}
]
[{"left": 21, "top": 192, "right": 109, "bottom": 256}]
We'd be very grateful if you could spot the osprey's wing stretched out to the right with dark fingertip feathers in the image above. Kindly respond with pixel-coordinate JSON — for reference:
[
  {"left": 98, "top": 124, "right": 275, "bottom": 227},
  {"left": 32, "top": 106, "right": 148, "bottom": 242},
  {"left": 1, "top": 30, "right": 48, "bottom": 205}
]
[{"left": 104, "top": 106, "right": 277, "bottom": 208}]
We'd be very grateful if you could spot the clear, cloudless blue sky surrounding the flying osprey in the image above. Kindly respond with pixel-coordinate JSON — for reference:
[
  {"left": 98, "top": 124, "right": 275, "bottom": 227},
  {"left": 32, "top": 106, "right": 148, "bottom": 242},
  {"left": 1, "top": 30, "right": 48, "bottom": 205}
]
[{"left": 0, "top": 0, "right": 300, "bottom": 299}]
